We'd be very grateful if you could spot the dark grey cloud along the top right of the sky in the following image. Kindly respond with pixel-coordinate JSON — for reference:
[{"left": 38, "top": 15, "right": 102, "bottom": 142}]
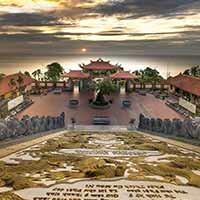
[{"left": 96, "top": 0, "right": 200, "bottom": 18}]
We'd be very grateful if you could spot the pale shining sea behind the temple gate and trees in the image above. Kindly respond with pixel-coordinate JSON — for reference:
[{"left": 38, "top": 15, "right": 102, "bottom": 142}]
[{"left": 0, "top": 55, "right": 200, "bottom": 78}]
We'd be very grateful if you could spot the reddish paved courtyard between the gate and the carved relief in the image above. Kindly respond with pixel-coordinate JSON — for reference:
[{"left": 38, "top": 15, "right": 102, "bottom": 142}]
[{"left": 18, "top": 92, "right": 183, "bottom": 125}]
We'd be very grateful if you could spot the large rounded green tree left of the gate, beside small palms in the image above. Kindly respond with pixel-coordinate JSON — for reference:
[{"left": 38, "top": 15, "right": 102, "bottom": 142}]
[{"left": 45, "top": 62, "right": 64, "bottom": 81}]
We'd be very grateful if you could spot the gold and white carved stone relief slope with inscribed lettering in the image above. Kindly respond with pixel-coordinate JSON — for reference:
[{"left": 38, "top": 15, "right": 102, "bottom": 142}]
[{"left": 0, "top": 130, "right": 200, "bottom": 200}]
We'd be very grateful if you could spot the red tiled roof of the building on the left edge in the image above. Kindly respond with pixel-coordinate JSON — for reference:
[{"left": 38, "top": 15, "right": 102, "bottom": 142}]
[{"left": 0, "top": 72, "right": 34, "bottom": 95}]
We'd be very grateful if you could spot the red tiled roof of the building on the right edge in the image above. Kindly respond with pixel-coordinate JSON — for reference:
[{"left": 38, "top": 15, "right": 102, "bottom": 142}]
[{"left": 167, "top": 74, "right": 200, "bottom": 96}]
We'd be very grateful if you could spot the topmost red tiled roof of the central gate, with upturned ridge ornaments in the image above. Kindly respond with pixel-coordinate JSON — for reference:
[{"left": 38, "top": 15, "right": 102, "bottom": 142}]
[{"left": 80, "top": 59, "right": 119, "bottom": 70}]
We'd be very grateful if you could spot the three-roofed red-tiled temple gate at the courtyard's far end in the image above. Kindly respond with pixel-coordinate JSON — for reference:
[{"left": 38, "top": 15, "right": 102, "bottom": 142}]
[{"left": 62, "top": 58, "right": 138, "bottom": 92}]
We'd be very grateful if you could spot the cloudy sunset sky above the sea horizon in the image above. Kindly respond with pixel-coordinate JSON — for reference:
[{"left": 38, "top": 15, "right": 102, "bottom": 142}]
[{"left": 0, "top": 0, "right": 200, "bottom": 56}]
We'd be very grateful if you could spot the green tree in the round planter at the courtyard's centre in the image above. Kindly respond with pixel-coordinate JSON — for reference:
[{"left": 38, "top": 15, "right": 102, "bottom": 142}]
[{"left": 94, "top": 79, "right": 117, "bottom": 105}]
